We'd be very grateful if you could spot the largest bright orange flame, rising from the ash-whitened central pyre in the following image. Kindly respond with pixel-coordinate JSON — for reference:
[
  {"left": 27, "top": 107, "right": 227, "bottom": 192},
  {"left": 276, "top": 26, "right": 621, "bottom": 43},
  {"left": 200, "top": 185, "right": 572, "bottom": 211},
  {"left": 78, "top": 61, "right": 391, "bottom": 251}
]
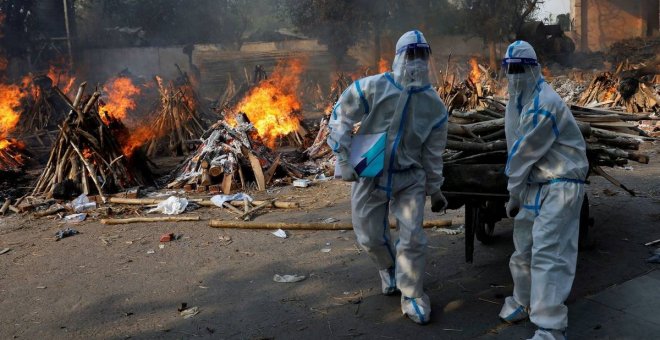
[{"left": 230, "top": 60, "right": 303, "bottom": 147}]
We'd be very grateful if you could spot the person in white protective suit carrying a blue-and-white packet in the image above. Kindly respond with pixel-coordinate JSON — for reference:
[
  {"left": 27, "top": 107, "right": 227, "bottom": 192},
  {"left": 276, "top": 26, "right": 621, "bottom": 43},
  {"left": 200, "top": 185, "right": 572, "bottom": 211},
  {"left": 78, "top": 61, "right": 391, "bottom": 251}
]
[{"left": 328, "top": 31, "right": 447, "bottom": 324}]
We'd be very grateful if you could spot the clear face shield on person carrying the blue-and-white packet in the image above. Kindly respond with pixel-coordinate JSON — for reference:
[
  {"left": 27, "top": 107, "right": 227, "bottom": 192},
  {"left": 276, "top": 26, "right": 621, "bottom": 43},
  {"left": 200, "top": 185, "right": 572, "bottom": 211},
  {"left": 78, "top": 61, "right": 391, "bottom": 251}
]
[{"left": 397, "top": 43, "right": 438, "bottom": 86}]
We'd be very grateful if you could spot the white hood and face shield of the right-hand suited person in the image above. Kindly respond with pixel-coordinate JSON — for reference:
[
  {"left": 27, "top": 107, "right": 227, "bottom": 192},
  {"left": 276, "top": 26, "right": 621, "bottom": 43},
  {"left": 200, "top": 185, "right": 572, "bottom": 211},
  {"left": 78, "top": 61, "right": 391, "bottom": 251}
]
[{"left": 502, "top": 40, "right": 542, "bottom": 114}]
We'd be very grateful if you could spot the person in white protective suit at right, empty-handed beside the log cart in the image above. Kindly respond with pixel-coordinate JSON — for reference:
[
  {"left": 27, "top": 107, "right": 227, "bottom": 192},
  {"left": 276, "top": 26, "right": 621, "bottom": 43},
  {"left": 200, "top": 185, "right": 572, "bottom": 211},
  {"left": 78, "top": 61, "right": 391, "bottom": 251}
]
[{"left": 500, "top": 41, "right": 589, "bottom": 339}]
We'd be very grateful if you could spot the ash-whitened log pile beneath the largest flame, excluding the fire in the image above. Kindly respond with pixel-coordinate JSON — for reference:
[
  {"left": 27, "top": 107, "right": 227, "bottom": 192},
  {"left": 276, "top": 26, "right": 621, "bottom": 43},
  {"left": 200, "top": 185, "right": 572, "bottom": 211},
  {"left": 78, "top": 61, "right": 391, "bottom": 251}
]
[{"left": 167, "top": 113, "right": 307, "bottom": 194}]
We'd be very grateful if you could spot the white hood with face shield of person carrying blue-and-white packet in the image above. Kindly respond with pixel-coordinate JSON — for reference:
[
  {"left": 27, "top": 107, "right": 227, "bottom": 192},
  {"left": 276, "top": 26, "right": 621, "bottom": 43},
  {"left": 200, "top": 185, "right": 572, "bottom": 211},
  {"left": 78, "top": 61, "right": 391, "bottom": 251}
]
[{"left": 392, "top": 31, "right": 431, "bottom": 86}]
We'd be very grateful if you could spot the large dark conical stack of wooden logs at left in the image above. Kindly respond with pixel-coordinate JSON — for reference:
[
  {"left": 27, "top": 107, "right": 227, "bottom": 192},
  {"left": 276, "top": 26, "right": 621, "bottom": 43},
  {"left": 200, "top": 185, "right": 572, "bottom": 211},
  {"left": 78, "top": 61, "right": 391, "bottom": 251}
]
[{"left": 32, "top": 82, "right": 148, "bottom": 198}]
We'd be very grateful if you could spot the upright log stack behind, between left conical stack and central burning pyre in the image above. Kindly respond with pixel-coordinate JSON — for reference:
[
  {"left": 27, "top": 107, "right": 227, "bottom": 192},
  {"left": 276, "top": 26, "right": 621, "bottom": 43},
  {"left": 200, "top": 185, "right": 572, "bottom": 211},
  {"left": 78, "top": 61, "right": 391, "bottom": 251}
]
[{"left": 144, "top": 77, "right": 207, "bottom": 157}]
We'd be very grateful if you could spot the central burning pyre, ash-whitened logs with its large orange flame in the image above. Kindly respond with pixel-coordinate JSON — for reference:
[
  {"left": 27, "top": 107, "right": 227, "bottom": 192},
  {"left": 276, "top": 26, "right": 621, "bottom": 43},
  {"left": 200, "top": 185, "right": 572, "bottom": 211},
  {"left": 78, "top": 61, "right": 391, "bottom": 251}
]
[{"left": 167, "top": 60, "right": 308, "bottom": 193}]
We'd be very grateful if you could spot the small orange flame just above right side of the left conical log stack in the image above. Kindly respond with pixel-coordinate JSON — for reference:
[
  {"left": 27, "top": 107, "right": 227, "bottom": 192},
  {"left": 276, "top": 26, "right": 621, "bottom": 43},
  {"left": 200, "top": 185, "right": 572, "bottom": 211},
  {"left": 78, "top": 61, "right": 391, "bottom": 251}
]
[{"left": 99, "top": 77, "right": 140, "bottom": 123}]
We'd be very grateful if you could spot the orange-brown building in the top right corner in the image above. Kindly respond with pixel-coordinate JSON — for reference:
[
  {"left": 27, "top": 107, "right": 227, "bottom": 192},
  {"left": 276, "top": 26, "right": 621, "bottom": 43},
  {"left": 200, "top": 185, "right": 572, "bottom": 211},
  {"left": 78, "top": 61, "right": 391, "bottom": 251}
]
[{"left": 570, "top": 0, "right": 660, "bottom": 52}]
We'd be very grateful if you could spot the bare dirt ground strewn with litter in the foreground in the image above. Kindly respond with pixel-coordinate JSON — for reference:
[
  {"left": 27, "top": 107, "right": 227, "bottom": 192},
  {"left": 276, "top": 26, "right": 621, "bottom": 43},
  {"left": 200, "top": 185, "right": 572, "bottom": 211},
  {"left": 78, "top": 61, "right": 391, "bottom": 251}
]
[{"left": 0, "top": 143, "right": 660, "bottom": 339}]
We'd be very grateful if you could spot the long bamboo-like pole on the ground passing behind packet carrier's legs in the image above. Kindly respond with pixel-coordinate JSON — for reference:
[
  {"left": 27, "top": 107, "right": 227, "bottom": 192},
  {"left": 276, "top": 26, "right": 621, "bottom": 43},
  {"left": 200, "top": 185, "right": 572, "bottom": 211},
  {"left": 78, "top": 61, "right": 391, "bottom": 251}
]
[{"left": 209, "top": 220, "right": 452, "bottom": 230}]
